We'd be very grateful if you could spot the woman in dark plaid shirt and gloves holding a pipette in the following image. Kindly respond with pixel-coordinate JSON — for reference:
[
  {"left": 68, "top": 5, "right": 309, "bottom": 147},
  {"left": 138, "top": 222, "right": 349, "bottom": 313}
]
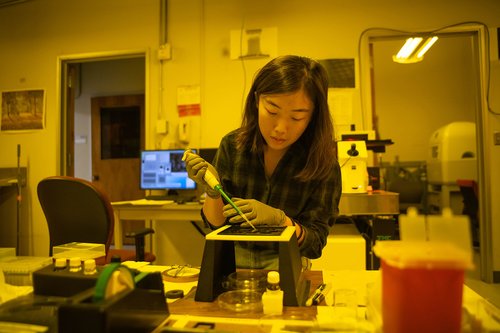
[{"left": 186, "top": 55, "right": 342, "bottom": 269}]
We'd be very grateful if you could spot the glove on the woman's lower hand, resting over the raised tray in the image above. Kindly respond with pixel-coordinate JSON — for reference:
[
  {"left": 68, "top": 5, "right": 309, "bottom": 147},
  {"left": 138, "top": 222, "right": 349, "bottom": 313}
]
[{"left": 223, "top": 198, "right": 286, "bottom": 226}]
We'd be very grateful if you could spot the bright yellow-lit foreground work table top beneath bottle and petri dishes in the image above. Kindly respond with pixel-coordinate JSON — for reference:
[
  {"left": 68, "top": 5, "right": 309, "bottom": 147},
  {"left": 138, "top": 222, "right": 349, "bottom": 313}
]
[{"left": 154, "top": 270, "right": 500, "bottom": 333}]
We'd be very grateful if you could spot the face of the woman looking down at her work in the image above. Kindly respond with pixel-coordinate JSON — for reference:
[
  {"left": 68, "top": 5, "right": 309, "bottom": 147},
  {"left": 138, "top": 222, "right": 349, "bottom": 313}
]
[{"left": 259, "top": 89, "right": 314, "bottom": 150}]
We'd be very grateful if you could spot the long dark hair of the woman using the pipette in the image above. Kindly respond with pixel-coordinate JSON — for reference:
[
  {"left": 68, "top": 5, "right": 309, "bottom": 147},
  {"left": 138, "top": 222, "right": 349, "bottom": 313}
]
[{"left": 237, "top": 55, "right": 336, "bottom": 181}]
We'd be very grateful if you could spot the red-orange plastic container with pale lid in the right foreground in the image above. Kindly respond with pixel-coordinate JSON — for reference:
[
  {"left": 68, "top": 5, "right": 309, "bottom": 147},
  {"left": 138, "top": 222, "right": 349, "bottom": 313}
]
[{"left": 375, "top": 241, "right": 471, "bottom": 333}]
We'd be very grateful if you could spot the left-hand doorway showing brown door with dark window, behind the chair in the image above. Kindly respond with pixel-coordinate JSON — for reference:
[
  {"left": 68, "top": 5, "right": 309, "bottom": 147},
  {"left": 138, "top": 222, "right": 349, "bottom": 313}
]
[{"left": 60, "top": 52, "right": 148, "bottom": 243}]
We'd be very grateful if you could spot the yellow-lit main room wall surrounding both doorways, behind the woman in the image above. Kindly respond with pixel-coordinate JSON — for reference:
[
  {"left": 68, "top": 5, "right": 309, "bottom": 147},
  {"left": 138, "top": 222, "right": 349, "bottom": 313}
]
[{"left": 0, "top": 0, "right": 500, "bottom": 278}]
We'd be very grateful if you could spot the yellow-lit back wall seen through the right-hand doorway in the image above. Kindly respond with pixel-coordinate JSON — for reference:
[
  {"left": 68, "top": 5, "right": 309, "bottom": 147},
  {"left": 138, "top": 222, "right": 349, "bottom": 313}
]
[{"left": 374, "top": 37, "right": 479, "bottom": 162}]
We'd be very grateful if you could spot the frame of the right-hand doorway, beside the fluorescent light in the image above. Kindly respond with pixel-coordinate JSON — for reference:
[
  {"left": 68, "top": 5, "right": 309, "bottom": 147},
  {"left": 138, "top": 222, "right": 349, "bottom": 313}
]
[{"left": 359, "top": 23, "right": 494, "bottom": 283}]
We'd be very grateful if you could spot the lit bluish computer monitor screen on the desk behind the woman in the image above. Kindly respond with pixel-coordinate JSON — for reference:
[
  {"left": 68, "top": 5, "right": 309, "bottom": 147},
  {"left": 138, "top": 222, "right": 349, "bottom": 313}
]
[{"left": 141, "top": 149, "right": 196, "bottom": 190}]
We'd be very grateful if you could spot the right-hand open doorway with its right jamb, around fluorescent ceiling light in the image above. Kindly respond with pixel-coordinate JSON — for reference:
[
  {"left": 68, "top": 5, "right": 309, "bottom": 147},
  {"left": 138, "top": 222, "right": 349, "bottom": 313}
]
[{"left": 365, "top": 26, "right": 493, "bottom": 282}]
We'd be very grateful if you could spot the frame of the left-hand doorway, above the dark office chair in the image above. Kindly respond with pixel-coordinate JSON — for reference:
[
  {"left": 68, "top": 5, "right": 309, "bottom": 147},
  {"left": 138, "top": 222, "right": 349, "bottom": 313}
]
[{"left": 57, "top": 49, "right": 150, "bottom": 176}]
